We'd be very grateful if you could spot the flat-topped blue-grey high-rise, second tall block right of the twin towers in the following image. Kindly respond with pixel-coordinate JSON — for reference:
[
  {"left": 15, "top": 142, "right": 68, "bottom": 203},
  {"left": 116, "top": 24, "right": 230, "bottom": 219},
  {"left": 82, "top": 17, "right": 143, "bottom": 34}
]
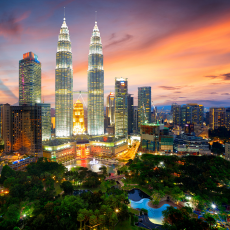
[{"left": 138, "top": 86, "right": 151, "bottom": 130}]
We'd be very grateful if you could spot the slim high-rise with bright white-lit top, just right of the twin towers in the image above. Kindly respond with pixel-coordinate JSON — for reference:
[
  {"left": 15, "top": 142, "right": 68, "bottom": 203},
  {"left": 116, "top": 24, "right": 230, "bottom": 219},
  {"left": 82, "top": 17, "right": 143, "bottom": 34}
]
[{"left": 115, "top": 78, "right": 128, "bottom": 137}]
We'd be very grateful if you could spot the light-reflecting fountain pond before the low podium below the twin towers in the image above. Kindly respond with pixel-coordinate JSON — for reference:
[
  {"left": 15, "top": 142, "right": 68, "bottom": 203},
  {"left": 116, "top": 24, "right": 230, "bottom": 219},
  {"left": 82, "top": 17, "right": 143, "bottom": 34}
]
[{"left": 64, "top": 159, "right": 115, "bottom": 173}]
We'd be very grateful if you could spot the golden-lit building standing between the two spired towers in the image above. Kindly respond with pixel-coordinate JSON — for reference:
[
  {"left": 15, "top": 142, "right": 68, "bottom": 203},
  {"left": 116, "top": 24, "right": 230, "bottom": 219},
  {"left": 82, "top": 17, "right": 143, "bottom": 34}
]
[{"left": 73, "top": 100, "right": 85, "bottom": 135}]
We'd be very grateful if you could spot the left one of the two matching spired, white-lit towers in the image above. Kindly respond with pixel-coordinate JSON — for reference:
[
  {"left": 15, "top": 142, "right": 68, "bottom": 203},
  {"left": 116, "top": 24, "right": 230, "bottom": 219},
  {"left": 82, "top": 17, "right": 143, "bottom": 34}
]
[{"left": 55, "top": 18, "right": 73, "bottom": 137}]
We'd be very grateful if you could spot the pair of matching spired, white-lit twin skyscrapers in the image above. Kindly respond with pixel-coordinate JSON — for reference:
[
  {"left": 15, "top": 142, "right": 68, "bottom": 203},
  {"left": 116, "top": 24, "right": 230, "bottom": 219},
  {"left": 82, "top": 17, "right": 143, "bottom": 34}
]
[{"left": 55, "top": 18, "right": 104, "bottom": 137}]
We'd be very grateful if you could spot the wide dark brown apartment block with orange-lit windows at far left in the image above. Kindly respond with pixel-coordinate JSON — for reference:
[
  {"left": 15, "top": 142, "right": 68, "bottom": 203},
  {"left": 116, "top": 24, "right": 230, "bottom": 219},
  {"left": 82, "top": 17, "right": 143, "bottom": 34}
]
[{"left": 2, "top": 104, "right": 42, "bottom": 157}]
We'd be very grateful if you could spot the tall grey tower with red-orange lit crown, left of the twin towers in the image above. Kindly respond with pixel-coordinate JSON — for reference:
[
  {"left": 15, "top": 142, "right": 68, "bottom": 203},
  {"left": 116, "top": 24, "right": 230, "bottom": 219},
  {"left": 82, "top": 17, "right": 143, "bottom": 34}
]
[{"left": 19, "top": 52, "right": 41, "bottom": 105}]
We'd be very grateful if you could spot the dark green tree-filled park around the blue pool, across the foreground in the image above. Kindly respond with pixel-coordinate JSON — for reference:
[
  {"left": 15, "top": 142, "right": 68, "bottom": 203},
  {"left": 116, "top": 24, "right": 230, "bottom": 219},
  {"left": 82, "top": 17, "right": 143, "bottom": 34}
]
[{"left": 0, "top": 154, "right": 230, "bottom": 230}]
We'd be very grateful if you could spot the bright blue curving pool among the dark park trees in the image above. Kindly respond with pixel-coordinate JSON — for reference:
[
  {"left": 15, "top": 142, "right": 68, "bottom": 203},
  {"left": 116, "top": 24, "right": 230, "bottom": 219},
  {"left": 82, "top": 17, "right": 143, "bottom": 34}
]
[{"left": 131, "top": 198, "right": 170, "bottom": 224}]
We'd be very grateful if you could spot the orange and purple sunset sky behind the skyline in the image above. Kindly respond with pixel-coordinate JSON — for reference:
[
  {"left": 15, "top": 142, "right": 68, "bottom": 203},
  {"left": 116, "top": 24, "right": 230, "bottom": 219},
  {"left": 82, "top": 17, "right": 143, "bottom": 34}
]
[{"left": 0, "top": 0, "right": 230, "bottom": 107}]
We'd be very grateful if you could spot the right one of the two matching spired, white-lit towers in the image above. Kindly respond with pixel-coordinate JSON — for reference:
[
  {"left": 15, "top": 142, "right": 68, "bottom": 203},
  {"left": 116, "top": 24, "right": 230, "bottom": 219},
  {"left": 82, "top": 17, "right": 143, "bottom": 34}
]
[{"left": 88, "top": 22, "right": 104, "bottom": 135}]
